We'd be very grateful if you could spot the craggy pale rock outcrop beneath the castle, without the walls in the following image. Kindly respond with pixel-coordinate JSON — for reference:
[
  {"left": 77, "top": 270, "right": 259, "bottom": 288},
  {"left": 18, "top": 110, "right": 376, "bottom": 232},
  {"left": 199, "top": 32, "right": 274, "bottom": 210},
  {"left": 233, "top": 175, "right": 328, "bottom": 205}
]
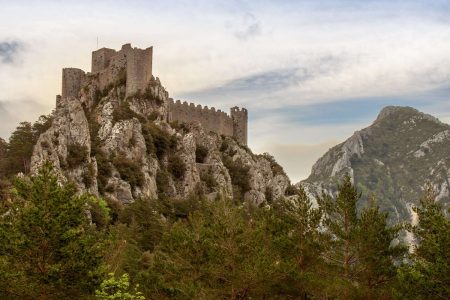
[{"left": 31, "top": 77, "right": 290, "bottom": 204}]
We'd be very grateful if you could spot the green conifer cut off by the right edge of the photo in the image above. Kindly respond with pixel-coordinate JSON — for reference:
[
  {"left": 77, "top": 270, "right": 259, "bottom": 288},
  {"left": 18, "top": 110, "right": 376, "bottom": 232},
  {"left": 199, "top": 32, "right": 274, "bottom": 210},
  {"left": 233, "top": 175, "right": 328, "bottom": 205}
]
[{"left": 398, "top": 187, "right": 450, "bottom": 299}]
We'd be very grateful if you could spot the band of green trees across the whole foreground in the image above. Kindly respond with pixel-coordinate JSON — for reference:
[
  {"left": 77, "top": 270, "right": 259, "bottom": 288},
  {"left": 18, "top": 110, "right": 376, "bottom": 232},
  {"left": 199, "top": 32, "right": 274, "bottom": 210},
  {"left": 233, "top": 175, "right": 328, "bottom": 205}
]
[{"left": 0, "top": 163, "right": 450, "bottom": 299}]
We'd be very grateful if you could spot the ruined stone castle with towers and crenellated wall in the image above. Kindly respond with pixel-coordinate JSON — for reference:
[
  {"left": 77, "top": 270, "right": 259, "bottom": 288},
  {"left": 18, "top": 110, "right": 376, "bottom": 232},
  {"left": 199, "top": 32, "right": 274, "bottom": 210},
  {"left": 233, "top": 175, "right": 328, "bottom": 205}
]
[{"left": 61, "top": 44, "right": 248, "bottom": 145}]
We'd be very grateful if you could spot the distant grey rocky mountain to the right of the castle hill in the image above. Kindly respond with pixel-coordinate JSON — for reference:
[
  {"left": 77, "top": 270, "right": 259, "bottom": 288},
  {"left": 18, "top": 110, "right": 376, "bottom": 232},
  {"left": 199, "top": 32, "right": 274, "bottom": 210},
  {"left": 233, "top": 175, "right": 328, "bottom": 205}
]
[{"left": 300, "top": 106, "right": 450, "bottom": 222}]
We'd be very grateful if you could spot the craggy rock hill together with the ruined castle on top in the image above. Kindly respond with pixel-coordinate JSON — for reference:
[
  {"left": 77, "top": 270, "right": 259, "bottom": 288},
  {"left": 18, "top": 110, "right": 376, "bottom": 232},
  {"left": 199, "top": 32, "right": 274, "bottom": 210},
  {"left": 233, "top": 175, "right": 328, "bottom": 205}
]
[{"left": 31, "top": 44, "right": 290, "bottom": 204}]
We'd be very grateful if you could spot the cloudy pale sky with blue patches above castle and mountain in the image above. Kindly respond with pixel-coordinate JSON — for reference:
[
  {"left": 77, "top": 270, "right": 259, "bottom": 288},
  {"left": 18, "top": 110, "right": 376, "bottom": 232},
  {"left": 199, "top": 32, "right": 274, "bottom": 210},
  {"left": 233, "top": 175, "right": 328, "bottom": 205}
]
[{"left": 0, "top": 0, "right": 450, "bottom": 182}]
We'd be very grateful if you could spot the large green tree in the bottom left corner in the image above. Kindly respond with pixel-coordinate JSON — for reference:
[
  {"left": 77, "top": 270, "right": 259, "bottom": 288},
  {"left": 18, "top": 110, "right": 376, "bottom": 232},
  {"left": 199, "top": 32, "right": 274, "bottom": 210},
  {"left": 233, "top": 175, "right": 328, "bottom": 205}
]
[{"left": 0, "top": 163, "right": 102, "bottom": 299}]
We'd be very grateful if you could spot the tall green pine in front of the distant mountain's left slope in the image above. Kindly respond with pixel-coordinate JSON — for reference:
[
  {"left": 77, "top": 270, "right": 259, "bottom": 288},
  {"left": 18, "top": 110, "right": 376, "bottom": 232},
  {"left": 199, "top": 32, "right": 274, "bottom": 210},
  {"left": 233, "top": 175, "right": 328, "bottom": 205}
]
[{"left": 319, "top": 175, "right": 405, "bottom": 299}]
